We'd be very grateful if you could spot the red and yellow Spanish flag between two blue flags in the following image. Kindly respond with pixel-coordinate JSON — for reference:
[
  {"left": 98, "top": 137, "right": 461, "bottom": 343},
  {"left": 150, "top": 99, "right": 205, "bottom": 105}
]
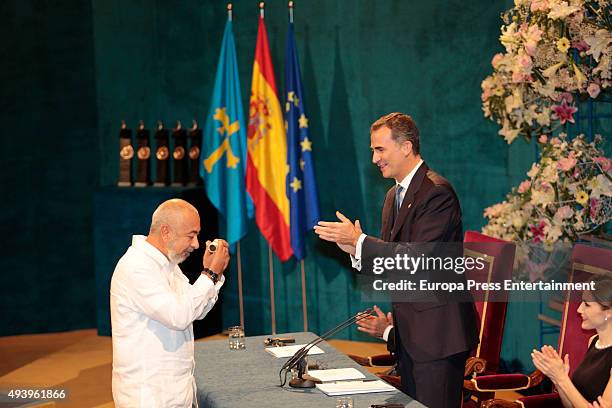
[{"left": 246, "top": 16, "right": 293, "bottom": 261}]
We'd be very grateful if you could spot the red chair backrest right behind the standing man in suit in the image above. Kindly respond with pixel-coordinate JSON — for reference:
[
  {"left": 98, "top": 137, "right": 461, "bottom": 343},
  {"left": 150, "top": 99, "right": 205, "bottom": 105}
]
[{"left": 464, "top": 231, "right": 515, "bottom": 374}]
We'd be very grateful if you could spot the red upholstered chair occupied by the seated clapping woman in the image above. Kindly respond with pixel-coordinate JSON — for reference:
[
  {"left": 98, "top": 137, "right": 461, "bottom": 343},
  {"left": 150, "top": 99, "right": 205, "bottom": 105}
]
[{"left": 482, "top": 244, "right": 612, "bottom": 408}]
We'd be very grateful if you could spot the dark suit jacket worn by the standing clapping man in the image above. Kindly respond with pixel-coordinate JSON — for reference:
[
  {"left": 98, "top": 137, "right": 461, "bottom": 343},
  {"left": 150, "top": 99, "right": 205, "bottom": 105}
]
[{"left": 361, "top": 163, "right": 478, "bottom": 362}]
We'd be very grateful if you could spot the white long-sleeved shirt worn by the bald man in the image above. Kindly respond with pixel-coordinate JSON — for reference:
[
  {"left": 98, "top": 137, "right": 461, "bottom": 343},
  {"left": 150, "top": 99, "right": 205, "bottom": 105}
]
[{"left": 110, "top": 235, "right": 225, "bottom": 408}]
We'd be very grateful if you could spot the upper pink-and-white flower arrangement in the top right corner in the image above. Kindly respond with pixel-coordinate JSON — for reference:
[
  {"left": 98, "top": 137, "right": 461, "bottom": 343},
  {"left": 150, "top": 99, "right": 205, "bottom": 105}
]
[{"left": 481, "top": 0, "right": 612, "bottom": 144}]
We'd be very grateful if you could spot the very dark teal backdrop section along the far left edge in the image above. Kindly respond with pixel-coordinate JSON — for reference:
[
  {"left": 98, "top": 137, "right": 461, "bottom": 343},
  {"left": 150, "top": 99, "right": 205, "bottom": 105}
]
[{"left": 0, "top": 0, "right": 100, "bottom": 335}]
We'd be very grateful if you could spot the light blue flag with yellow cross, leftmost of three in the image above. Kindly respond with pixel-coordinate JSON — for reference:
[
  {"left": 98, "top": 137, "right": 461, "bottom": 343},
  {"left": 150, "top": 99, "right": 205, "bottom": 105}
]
[{"left": 200, "top": 20, "right": 253, "bottom": 244}]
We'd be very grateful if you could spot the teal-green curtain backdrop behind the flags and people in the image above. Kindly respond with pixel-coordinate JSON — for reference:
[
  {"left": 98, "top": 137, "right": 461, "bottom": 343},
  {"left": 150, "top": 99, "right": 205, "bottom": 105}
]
[{"left": 0, "top": 0, "right": 608, "bottom": 372}]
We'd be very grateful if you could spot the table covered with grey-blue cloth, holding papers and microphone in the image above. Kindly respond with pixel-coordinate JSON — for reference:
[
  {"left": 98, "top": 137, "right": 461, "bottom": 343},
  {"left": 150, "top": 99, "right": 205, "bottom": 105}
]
[{"left": 195, "top": 333, "right": 424, "bottom": 408}]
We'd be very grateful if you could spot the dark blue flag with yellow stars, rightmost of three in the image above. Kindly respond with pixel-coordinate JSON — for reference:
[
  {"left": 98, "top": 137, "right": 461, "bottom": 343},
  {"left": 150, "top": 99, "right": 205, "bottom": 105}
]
[{"left": 285, "top": 22, "right": 319, "bottom": 260}]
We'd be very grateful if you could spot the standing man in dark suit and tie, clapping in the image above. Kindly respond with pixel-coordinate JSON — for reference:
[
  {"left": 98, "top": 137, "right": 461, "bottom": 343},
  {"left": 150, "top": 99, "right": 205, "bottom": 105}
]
[{"left": 315, "top": 113, "right": 478, "bottom": 408}]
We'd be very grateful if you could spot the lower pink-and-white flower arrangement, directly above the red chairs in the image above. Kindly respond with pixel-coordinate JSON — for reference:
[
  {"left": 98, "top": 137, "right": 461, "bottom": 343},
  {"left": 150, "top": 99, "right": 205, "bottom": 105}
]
[{"left": 482, "top": 133, "right": 612, "bottom": 245}]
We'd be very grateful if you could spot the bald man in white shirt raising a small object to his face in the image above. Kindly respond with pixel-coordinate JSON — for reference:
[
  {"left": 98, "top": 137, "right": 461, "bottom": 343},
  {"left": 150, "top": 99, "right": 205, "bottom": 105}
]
[{"left": 110, "top": 199, "right": 229, "bottom": 408}]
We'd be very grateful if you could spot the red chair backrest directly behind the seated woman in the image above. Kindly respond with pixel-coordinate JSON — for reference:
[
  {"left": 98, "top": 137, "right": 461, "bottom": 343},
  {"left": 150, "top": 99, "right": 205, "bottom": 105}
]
[{"left": 558, "top": 244, "right": 612, "bottom": 376}]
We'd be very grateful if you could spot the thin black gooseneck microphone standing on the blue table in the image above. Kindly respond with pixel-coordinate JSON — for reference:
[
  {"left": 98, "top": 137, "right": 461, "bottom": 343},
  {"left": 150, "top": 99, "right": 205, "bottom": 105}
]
[{"left": 278, "top": 308, "right": 372, "bottom": 388}]
